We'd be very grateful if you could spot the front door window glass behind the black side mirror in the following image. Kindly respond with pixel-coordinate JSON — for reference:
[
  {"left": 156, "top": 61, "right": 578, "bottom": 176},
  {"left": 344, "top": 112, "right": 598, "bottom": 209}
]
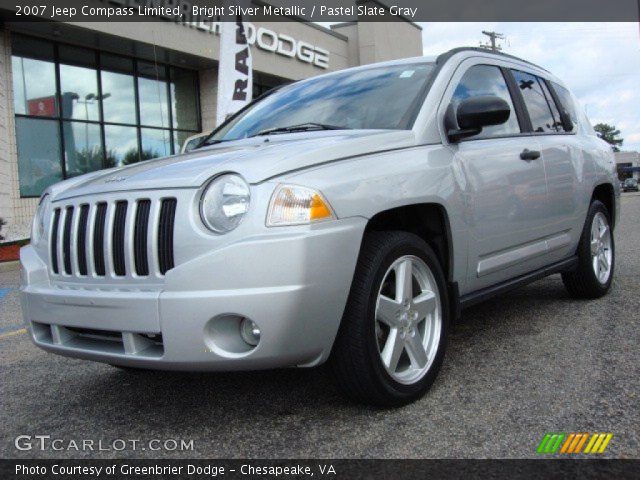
[{"left": 451, "top": 65, "right": 520, "bottom": 138}]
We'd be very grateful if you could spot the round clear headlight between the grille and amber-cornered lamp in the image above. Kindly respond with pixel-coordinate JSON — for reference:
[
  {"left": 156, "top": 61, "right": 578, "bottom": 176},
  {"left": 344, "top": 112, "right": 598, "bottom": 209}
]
[{"left": 200, "top": 173, "right": 251, "bottom": 233}]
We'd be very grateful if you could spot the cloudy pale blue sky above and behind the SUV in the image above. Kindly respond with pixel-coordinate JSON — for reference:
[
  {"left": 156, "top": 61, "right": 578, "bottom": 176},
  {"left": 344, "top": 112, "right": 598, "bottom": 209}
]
[{"left": 420, "top": 22, "right": 640, "bottom": 150}]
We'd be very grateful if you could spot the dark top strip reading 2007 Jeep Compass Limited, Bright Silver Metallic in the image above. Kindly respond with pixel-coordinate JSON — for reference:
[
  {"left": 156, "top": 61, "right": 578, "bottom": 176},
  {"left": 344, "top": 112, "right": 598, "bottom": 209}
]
[{"left": 0, "top": 0, "right": 640, "bottom": 24}]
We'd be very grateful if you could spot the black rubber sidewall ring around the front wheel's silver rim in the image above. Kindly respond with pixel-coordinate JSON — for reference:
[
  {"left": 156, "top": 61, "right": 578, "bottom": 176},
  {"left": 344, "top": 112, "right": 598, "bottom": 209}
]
[{"left": 363, "top": 234, "right": 449, "bottom": 400}]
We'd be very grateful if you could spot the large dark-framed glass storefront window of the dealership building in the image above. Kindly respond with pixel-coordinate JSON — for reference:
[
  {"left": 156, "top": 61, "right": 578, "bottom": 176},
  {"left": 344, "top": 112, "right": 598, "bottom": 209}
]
[{"left": 12, "top": 34, "right": 200, "bottom": 196}]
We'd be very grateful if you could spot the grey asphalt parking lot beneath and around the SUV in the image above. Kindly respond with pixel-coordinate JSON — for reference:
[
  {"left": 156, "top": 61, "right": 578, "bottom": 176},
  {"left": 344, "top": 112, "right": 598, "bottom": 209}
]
[{"left": 0, "top": 194, "right": 640, "bottom": 458}]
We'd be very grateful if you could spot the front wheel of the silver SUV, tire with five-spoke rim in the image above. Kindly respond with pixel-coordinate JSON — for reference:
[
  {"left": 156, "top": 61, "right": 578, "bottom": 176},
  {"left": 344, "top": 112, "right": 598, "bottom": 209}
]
[{"left": 331, "top": 232, "right": 449, "bottom": 407}]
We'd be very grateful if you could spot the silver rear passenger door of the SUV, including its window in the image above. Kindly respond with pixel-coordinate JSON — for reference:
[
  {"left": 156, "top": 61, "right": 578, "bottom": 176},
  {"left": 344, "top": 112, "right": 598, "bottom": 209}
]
[{"left": 512, "top": 70, "right": 584, "bottom": 263}]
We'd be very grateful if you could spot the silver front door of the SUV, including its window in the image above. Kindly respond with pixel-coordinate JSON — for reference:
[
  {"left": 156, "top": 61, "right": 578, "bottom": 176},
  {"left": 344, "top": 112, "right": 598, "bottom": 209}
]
[{"left": 443, "top": 59, "right": 548, "bottom": 294}]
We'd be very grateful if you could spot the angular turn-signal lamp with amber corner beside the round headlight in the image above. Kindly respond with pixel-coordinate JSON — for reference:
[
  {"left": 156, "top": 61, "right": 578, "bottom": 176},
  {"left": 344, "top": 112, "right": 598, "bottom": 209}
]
[{"left": 267, "top": 185, "right": 335, "bottom": 227}]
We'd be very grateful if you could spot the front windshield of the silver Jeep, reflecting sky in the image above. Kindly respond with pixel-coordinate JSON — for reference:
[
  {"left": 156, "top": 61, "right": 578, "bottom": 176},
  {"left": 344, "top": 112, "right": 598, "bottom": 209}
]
[{"left": 207, "top": 63, "right": 434, "bottom": 143}]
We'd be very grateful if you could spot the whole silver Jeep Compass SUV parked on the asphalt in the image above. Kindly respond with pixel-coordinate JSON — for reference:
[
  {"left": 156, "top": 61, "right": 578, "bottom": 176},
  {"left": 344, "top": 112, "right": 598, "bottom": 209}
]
[{"left": 21, "top": 48, "right": 620, "bottom": 405}]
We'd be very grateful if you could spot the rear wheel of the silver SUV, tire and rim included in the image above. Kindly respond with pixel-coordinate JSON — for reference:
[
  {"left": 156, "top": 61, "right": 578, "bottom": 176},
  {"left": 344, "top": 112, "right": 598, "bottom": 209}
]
[{"left": 562, "top": 200, "right": 615, "bottom": 299}]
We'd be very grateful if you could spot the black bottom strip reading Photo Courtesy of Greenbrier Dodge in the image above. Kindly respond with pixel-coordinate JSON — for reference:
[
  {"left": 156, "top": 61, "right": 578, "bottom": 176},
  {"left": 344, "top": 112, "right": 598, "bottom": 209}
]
[{"left": 0, "top": 459, "right": 640, "bottom": 480}]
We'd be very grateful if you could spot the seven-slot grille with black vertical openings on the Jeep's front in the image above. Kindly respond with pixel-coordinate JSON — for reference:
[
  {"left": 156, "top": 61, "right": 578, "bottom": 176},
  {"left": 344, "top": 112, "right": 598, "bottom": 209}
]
[{"left": 49, "top": 198, "right": 177, "bottom": 278}]
